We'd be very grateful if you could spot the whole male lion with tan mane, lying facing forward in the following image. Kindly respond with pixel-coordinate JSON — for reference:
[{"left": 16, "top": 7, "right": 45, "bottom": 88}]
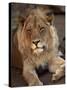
[{"left": 14, "top": 8, "right": 65, "bottom": 86}]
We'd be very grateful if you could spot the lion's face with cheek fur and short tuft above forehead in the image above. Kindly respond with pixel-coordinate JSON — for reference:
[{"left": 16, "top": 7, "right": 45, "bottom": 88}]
[{"left": 19, "top": 8, "right": 57, "bottom": 54}]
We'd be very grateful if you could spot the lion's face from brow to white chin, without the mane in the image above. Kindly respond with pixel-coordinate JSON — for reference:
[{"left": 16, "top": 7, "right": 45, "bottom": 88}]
[{"left": 27, "top": 17, "right": 49, "bottom": 54}]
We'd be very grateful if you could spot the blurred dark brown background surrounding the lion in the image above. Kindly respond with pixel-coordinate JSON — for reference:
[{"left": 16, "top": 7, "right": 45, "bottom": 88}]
[{"left": 10, "top": 3, "right": 65, "bottom": 87}]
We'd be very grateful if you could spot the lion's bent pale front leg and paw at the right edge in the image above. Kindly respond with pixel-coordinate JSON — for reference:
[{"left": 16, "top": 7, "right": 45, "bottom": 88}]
[{"left": 49, "top": 57, "right": 65, "bottom": 81}]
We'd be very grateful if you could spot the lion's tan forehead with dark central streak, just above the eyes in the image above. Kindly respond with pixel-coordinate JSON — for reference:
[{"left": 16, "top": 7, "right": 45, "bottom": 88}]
[{"left": 27, "top": 15, "right": 49, "bottom": 29}]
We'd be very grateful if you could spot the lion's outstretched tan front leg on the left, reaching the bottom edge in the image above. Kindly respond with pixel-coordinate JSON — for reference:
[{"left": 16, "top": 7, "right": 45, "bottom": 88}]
[{"left": 23, "top": 60, "right": 43, "bottom": 86}]
